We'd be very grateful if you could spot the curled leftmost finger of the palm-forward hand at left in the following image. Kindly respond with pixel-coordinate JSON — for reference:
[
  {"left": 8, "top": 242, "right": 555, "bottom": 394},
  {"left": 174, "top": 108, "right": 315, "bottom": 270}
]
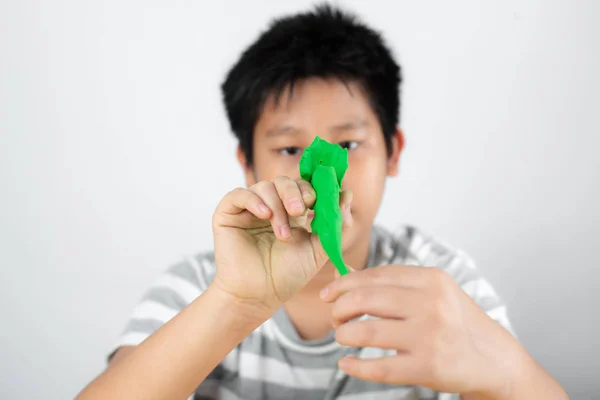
[{"left": 214, "top": 188, "right": 272, "bottom": 228}]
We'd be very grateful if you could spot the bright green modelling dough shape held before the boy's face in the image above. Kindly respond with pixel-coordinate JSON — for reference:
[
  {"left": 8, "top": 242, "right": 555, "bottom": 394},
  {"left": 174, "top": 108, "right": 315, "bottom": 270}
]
[{"left": 300, "top": 136, "right": 348, "bottom": 276}]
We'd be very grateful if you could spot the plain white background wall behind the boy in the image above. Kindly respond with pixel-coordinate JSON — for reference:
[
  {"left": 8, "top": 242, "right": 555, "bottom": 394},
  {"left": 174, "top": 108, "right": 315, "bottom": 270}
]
[{"left": 0, "top": 0, "right": 600, "bottom": 399}]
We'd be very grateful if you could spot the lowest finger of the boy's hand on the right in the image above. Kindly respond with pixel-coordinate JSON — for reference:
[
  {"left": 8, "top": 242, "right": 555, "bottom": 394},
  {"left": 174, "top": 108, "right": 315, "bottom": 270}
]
[{"left": 338, "top": 354, "right": 431, "bottom": 386}]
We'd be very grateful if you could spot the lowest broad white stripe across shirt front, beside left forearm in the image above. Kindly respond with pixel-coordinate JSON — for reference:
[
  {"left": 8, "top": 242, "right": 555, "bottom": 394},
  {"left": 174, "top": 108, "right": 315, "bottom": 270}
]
[{"left": 221, "top": 350, "right": 335, "bottom": 389}]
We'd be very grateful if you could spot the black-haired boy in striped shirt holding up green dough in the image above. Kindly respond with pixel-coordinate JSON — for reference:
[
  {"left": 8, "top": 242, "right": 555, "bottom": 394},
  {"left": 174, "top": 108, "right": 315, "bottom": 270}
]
[{"left": 80, "top": 6, "right": 566, "bottom": 399}]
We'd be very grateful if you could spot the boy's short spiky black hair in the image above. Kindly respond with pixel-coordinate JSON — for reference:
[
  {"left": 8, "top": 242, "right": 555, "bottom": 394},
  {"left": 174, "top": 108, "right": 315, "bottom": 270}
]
[{"left": 221, "top": 4, "right": 402, "bottom": 165}]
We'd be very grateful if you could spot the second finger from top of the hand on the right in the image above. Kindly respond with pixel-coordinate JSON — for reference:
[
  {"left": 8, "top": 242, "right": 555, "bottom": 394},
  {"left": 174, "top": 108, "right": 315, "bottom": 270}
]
[{"left": 331, "top": 285, "right": 427, "bottom": 328}]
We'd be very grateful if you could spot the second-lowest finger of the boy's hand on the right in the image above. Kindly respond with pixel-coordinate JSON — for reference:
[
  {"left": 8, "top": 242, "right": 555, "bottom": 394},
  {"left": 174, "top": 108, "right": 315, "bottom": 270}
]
[{"left": 335, "top": 319, "right": 411, "bottom": 352}]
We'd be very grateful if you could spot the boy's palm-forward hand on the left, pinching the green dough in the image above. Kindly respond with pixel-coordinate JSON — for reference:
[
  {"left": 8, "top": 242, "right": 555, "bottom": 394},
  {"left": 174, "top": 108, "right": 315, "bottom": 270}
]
[{"left": 213, "top": 177, "right": 352, "bottom": 312}]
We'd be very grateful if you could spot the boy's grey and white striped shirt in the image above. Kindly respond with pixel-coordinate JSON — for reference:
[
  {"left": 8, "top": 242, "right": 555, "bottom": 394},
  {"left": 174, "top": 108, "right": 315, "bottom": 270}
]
[{"left": 115, "top": 226, "right": 512, "bottom": 400}]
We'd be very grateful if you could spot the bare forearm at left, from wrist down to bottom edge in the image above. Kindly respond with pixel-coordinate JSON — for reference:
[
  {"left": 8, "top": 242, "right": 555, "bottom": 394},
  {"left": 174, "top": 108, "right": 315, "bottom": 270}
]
[{"left": 77, "top": 285, "right": 269, "bottom": 400}]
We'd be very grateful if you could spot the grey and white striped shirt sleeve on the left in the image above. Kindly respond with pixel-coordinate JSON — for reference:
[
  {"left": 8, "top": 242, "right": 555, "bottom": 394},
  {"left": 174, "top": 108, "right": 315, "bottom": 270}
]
[{"left": 108, "top": 255, "right": 215, "bottom": 359}]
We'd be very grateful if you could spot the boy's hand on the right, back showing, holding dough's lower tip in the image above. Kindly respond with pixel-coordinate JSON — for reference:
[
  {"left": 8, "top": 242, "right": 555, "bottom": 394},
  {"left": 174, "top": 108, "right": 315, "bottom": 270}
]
[{"left": 321, "top": 265, "right": 524, "bottom": 399}]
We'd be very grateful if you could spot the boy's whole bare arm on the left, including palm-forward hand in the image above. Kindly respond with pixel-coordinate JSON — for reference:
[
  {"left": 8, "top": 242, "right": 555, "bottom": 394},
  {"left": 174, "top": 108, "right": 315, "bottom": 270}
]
[{"left": 78, "top": 177, "right": 330, "bottom": 400}]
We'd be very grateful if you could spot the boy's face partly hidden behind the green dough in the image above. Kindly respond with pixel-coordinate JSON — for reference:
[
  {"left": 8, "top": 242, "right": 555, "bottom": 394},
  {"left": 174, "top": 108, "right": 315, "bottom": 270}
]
[{"left": 238, "top": 78, "right": 403, "bottom": 250}]
